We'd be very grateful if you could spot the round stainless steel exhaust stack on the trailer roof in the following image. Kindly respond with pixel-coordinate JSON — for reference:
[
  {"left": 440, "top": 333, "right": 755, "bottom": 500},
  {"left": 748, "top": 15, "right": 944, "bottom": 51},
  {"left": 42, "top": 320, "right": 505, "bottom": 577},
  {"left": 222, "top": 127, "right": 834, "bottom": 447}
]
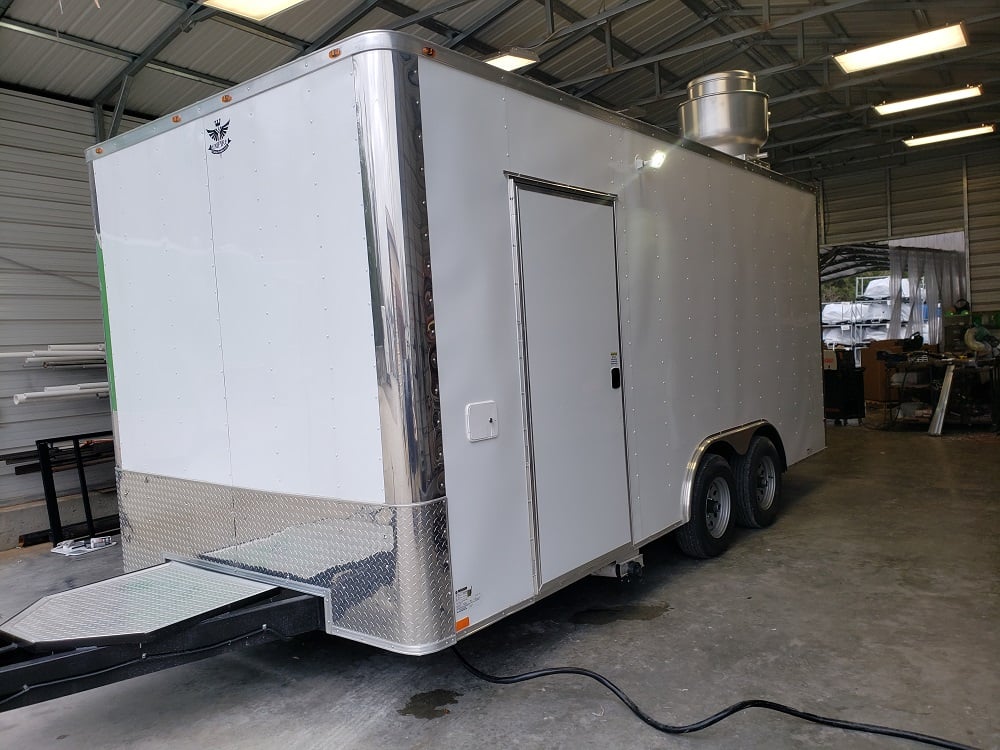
[{"left": 679, "top": 70, "right": 768, "bottom": 159}]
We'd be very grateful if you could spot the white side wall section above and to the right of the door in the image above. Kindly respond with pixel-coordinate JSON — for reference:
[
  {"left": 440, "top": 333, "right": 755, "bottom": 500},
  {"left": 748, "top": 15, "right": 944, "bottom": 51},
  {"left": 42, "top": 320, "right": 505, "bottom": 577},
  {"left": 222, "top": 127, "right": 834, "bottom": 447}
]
[{"left": 506, "top": 82, "right": 824, "bottom": 542}]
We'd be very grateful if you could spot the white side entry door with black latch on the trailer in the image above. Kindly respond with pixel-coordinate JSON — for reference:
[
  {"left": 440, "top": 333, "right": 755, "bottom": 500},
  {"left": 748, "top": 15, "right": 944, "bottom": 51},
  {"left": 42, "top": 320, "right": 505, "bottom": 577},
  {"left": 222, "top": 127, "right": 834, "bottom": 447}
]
[{"left": 512, "top": 178, "right": 631, "bottom": 586}]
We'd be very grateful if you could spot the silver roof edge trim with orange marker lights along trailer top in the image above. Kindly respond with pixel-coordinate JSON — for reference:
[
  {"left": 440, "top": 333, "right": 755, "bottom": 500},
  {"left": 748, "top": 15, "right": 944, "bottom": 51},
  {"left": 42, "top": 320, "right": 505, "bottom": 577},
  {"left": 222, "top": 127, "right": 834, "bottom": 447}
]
[{"left": 86, "top": 31, "right": 816, "bottom": 193}]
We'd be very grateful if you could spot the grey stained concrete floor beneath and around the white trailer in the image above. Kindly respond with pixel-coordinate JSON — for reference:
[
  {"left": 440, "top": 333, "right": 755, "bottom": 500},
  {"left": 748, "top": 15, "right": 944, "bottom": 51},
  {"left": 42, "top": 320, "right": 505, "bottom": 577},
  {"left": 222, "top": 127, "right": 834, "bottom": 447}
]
[{"left": 0, "top": 426, "right": 1000, "bottom": 750}]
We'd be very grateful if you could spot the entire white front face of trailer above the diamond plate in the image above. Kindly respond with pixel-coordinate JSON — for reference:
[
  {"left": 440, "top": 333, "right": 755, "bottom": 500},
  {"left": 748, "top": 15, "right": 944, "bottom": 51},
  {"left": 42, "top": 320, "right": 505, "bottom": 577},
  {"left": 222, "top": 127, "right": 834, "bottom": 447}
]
[{"left": 93, "top": 66, "right": 384, "bottom": 502}]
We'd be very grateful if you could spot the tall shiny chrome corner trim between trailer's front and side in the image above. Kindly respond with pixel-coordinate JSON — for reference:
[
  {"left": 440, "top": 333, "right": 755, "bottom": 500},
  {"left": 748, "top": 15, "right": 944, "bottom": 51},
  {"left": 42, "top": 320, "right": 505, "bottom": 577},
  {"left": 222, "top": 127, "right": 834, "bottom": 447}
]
[{"left": 354, "top": 50, "right": 445, "bottom": 505}]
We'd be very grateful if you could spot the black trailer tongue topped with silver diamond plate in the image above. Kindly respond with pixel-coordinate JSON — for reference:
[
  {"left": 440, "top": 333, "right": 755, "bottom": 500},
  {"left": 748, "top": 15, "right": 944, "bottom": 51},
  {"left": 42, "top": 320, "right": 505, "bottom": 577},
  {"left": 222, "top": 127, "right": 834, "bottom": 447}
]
[{"left": 0, "top": 561, "right": 323, "bottom": 710}]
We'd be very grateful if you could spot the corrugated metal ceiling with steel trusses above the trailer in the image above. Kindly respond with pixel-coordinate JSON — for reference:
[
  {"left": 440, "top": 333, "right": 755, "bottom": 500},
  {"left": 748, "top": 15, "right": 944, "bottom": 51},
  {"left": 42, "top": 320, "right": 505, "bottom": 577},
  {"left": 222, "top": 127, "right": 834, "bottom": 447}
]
[{"left": 0, "top": 0, "right": 1000, "bottom": 181}]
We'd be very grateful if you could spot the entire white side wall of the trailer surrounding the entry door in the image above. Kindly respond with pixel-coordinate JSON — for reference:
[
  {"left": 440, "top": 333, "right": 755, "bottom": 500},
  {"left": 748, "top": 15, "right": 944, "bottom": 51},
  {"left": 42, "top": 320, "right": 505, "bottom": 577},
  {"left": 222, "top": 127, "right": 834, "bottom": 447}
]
[{"left": 420, "top": 64, "right": 824, "bottom": 625}]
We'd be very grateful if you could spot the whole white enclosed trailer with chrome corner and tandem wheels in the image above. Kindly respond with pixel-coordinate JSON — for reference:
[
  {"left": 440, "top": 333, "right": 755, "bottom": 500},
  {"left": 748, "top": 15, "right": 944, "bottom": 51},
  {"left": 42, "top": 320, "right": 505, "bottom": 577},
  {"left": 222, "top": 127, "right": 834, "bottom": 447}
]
[{"left": 3, "top": 32, "right": 824, "bottom": 680}]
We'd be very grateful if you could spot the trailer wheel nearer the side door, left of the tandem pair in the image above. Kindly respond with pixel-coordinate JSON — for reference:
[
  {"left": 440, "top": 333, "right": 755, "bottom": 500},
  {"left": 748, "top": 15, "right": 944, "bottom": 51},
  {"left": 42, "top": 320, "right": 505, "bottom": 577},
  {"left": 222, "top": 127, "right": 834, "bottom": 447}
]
[{"left": 677, "top": 454, "right": 736, "bottom": 557}]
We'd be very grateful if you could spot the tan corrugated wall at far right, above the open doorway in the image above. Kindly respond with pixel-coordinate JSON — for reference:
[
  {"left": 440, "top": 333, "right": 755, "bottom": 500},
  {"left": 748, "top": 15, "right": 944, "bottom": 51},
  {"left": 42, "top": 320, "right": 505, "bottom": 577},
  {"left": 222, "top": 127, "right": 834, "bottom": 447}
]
[{"left": 821, "top": 151, "right": 1000, "bottom": 312}]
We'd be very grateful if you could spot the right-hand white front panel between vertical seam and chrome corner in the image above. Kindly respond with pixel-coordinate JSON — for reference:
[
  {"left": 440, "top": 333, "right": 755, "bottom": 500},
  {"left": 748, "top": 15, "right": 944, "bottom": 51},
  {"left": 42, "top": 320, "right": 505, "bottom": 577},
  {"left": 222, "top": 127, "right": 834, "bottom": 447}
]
[{"left": 199, "top": 61, "right": 385, "bottom": 502}]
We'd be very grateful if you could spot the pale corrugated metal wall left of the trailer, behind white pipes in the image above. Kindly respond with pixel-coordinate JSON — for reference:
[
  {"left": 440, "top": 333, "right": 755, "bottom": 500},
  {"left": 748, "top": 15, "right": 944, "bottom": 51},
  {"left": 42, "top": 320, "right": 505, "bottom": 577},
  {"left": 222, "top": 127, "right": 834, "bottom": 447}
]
[{"left": 0, "top": 89, "right": 143, "bottom": 549}]
